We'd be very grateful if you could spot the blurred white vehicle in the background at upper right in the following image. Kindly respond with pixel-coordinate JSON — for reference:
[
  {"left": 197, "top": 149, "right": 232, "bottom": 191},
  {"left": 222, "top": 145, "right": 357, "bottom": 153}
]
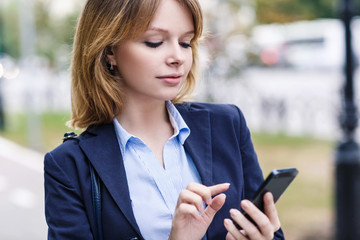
[{"left": 251, "top": 18, "right": 360, "bottom": 69}]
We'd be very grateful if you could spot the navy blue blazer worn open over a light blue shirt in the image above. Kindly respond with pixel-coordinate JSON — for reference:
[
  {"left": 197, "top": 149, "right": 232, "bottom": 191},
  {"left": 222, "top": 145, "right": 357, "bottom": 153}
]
[{"left": 44, "top": 103, "right": 283, "bottom": 240}]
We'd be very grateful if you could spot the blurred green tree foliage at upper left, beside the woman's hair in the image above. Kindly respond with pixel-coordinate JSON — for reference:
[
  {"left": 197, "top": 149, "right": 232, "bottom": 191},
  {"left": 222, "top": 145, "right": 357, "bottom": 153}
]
[{"left": 0, "top": 0, "right": 80, "bottom": 68}]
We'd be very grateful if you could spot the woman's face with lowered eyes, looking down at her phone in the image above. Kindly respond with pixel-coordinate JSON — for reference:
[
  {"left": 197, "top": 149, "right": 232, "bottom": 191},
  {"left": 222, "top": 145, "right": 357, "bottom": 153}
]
[{"left": 107, "top": 0, "right": 194, "bottom": 104}]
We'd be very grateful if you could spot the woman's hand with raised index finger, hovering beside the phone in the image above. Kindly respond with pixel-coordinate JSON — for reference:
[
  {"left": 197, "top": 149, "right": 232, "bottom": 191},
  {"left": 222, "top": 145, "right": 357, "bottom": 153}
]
[{"left": 169, "top": 183, "right": 230, "bottom": 240}]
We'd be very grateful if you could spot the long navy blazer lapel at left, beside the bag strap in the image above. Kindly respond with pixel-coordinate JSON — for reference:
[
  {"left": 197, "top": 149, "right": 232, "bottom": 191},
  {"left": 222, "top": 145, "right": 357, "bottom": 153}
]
[{"left": 80, "top": 123, "right": 140, "bottom": 234}]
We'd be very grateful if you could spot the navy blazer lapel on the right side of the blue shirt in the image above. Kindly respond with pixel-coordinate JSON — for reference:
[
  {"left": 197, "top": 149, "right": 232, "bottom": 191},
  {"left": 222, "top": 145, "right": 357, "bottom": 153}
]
[{"left": 175, "top": 104, "right": 213, "bottom": 186}]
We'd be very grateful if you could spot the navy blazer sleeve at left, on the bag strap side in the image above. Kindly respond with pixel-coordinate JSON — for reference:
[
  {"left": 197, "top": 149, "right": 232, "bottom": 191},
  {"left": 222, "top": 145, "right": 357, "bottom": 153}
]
[{"left": 44, "top": 153, "right": 94, "bottom": 240}]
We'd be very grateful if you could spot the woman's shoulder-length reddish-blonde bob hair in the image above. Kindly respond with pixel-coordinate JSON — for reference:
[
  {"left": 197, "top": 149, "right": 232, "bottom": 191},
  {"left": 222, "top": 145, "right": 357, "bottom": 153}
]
[{"left": 68, "top": 0, "right": 203, "bottom": 129}]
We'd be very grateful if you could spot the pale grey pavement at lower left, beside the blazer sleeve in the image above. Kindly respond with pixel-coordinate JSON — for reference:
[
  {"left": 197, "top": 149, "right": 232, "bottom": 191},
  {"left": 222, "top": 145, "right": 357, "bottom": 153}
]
[{"left": 0, "top": 138, "right": 47, "bottom": 240}]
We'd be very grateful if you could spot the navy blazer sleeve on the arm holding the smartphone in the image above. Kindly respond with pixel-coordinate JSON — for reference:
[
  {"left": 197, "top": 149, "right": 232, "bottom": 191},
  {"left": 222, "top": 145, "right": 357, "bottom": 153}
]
[{"left": 235, "top": 106, "right": 285, "bottom": 240}]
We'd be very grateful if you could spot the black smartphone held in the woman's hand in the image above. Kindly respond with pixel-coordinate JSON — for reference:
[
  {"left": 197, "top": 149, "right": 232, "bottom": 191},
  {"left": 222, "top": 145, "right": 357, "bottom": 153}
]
[{"left": 234, "top": 168, "right": 299, "bottom": 229}]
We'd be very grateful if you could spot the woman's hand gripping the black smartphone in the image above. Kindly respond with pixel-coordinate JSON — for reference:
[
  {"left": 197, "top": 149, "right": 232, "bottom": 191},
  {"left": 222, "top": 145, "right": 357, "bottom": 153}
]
[{"left": 224, "top": 192, "right": 280, "bottom": 240}]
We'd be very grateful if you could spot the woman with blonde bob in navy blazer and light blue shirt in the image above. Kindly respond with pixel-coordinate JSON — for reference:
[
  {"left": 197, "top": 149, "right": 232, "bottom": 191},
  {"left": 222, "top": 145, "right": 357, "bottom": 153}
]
[{"left": 45, "top": 0, "right": 283, "bottom": 240}]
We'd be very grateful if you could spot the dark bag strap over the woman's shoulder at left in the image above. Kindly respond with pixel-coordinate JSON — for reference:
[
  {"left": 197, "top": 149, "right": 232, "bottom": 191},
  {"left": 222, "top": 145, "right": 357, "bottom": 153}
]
[{"left": 63, "top": 132, "right": 103, "bottom": 240}]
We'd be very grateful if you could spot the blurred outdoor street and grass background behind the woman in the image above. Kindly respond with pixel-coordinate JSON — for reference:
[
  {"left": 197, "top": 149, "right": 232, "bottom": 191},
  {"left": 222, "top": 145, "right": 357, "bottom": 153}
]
[{"left": 0, "top": 0, "right": 360, "bottom": 240}]
